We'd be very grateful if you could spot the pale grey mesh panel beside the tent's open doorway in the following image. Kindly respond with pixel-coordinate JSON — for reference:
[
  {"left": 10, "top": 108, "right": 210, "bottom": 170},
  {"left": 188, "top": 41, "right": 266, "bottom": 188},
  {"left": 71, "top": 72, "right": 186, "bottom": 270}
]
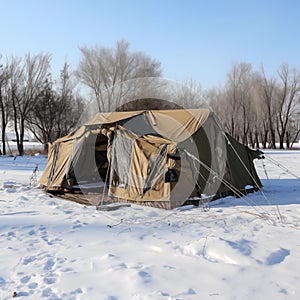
[{"left": 110, "top": 131, "right": 134, "bottom": 189}]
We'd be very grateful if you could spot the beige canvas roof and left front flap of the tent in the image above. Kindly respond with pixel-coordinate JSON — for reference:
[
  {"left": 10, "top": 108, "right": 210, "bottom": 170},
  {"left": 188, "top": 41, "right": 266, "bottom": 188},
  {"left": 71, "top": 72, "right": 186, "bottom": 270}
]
[{"left": 40, "top": 109, "right": 210, "bottom": 191}]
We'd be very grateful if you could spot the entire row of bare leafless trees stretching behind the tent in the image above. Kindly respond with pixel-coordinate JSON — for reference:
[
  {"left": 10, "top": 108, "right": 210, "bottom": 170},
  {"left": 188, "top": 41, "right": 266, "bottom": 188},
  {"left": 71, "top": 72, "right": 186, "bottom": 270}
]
[{"left": 0, "top": 41, "right": 300, "bottom": 155}]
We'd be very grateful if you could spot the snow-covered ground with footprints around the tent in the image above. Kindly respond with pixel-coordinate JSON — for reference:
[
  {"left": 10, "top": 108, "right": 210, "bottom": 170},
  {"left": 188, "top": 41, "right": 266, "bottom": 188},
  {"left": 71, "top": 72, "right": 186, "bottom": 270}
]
[{"left": 0, "top": 151, "right": 300, "bottom": 300}]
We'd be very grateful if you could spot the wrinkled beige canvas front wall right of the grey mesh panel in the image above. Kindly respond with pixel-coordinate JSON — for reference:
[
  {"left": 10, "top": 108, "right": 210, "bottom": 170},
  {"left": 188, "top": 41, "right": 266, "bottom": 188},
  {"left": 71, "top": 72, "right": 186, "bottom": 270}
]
[{"left": 109, "top": 128, "right": 176, "bottom": 202}]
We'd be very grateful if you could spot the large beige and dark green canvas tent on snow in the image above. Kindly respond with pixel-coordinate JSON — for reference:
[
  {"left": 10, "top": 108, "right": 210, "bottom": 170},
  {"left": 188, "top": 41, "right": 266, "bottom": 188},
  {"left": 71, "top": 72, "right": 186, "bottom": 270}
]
[{"left": 40, "top": 109, "right": 262, "bottom": 209}]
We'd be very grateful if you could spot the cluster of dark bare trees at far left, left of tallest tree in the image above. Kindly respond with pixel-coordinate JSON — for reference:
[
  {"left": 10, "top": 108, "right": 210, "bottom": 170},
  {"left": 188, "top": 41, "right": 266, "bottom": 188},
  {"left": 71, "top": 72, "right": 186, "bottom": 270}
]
[{"left": 0, "top": 53, "right": 84, "bottom": 155}]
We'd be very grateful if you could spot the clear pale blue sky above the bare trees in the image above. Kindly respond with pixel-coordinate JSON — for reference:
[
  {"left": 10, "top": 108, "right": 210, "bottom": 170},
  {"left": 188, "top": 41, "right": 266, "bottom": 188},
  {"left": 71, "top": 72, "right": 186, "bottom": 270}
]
[{"left": 0, "top": 0, "right": 300, "bottom": 89}]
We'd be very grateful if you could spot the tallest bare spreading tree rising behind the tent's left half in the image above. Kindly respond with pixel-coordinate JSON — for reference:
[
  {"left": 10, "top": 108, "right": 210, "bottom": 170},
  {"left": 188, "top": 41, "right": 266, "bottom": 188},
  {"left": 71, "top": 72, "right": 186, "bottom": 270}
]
[{"left": 76, "top": 41, "right": 161, "bottom": 111}]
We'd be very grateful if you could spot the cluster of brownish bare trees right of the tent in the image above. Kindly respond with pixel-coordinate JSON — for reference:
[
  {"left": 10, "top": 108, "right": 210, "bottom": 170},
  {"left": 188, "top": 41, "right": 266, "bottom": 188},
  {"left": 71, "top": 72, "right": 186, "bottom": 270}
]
[{"left": 206, "top": 63, "right": 300, "bottom": 149}]
